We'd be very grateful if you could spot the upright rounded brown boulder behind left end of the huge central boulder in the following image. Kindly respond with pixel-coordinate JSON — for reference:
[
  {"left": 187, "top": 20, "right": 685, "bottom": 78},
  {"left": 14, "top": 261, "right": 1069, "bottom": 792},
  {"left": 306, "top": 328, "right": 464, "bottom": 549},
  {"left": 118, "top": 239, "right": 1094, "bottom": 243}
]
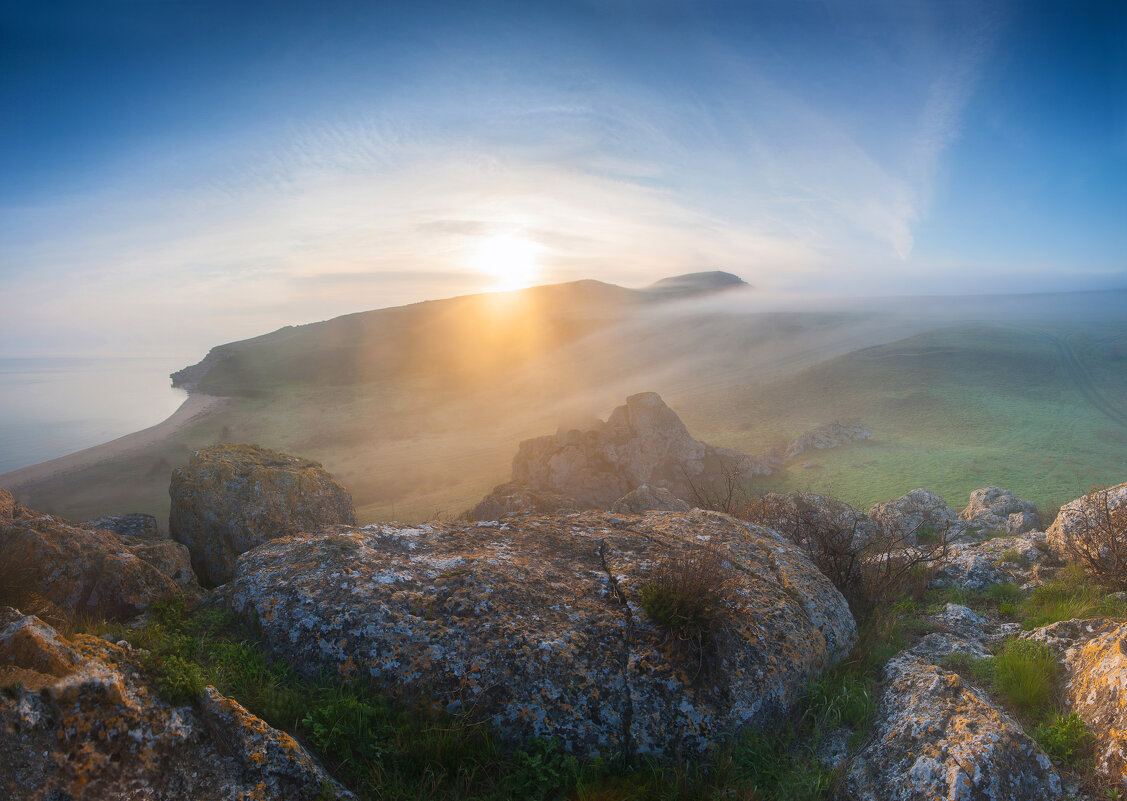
[{"left": 168, "top": 443, "right": 356, "bottom": 585}]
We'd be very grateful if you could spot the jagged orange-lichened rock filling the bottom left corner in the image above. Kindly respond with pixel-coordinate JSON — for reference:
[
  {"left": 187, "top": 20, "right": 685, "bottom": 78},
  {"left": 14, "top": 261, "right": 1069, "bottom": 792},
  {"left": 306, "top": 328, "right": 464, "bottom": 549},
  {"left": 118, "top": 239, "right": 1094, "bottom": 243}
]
[{"left": 0, "top": 607, "right": 352, "bottom": 801}]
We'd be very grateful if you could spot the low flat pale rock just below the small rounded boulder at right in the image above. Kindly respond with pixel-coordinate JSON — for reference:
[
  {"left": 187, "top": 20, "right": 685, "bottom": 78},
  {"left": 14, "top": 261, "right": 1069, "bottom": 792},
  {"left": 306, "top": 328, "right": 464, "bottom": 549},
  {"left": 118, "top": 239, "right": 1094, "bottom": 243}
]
[{"left": 931, "top": 532, "right": 1048, "bottom": 589}]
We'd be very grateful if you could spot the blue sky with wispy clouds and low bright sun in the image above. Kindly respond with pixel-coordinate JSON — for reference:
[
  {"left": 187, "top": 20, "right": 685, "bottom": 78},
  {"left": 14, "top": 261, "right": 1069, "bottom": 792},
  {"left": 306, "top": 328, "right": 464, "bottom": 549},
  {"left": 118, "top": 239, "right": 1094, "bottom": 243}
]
[{"left": 0, "top": 0, "right": 1127, "bottom": 361}]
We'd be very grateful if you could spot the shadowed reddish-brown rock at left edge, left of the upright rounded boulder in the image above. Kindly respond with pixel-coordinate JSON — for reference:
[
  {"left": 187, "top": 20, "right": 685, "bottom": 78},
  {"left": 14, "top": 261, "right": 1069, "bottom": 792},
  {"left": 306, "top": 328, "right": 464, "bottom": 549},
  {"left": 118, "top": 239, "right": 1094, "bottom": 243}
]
[{"left": 0, "top": 506, "right": 184, "bottom": 618}]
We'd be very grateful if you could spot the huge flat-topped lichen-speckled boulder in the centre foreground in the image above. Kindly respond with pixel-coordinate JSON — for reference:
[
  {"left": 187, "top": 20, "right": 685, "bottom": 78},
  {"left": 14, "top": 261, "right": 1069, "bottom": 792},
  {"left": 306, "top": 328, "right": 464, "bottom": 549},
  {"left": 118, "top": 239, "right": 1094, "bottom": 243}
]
[{"left": 223, "top": 510, "right": 855, "bottom": 756}]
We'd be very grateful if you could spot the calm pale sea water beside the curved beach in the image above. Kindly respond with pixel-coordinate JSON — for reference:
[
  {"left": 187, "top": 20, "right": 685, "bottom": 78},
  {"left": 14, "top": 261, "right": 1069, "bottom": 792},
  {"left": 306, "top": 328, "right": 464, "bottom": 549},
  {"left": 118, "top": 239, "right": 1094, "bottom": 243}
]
[{"left": 0, "top": 358, "right": 187, "bottom": 473}]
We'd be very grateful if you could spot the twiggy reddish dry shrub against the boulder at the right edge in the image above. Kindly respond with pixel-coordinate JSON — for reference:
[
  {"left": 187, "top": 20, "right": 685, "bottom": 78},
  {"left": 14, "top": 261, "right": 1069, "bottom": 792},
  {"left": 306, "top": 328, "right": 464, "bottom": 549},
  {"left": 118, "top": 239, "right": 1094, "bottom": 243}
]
[{"left": 1059, "top": 488, "right": 1127, "bottom": 589}]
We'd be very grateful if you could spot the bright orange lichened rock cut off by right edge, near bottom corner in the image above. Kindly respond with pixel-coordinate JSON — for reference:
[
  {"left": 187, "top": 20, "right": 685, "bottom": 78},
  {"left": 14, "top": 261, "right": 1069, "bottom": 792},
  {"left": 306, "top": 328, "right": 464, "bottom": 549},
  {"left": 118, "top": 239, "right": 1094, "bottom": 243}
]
[{"left": 1023, "top": 620, "right": 1127, "bottom": 790}]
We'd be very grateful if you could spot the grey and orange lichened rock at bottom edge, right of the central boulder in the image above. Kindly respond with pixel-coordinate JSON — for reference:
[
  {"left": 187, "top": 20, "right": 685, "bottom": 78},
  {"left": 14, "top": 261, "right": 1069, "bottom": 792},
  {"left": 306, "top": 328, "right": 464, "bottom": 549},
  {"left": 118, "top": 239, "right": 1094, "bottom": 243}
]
[{"left": 841, "top": 652, "right": 1062, "bottom": 801}]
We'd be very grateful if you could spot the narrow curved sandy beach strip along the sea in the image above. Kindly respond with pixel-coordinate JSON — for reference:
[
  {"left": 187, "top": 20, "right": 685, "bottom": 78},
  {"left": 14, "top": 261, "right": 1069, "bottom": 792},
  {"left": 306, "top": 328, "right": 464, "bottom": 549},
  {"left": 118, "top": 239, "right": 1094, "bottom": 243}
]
[{"left": 0, "top": 393, "right": 231, "bottom": 492}]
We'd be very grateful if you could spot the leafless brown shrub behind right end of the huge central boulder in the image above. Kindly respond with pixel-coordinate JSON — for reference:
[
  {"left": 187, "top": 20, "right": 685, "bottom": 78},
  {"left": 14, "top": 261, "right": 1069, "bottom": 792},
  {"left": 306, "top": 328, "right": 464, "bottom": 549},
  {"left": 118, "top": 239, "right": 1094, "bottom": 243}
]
[{"left": 744, "top": 495, "right": 952, "bottom": 621}]
